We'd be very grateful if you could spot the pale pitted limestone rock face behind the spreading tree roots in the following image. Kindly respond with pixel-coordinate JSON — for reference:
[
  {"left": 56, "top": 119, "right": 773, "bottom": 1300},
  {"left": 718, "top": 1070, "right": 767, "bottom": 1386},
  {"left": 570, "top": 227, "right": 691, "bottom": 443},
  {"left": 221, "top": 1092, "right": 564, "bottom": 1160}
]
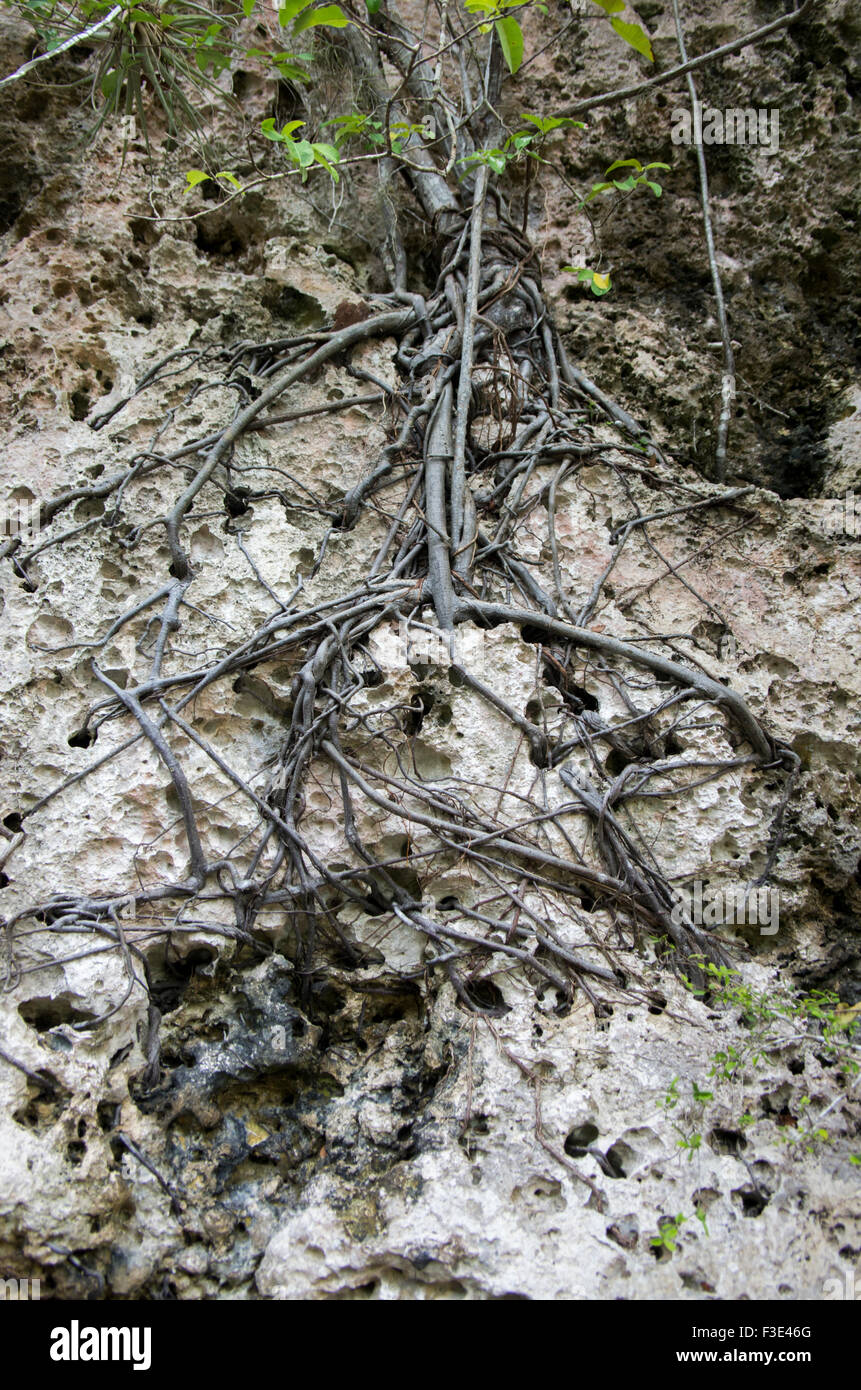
[{"left": 0, "top": 0, "right": 861, "bottom": 1300}]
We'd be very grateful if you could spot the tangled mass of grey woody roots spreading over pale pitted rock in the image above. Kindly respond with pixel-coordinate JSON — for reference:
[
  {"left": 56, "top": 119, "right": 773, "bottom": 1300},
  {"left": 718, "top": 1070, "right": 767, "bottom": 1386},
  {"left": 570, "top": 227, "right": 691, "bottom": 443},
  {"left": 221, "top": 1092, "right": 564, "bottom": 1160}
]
[{"left": 6, "top": 184, "right": 789, "bottom": 1070}]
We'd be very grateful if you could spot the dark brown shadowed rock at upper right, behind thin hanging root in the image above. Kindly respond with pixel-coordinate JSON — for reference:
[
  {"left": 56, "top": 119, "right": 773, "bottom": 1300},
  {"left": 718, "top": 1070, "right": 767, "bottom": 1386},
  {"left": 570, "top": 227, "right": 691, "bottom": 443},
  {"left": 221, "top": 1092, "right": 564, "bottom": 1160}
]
[{"left": 517, "top": 0, "right": 861, "bottom": 498}]
